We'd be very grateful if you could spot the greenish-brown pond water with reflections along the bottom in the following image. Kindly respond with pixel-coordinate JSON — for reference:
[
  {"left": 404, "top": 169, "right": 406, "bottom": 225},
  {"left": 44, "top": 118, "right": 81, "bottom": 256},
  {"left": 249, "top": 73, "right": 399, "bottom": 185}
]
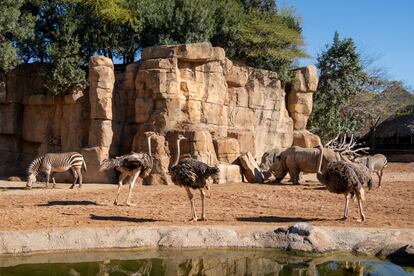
[{"left": 0, "top": 250, "right": 414, "bottom": 276}]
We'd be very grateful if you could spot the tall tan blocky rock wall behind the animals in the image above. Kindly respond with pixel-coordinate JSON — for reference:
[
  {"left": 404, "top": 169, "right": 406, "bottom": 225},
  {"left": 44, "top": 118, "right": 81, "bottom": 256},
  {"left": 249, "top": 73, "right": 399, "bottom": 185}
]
[{"left": 0, "top": 43, "right": 317, "bottom": 184}]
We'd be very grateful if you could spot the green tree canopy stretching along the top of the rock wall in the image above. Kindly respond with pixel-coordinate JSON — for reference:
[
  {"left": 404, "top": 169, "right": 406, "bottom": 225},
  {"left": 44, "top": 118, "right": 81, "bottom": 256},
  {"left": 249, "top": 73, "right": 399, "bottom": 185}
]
[{"left": 0, "top": 0, "right": 305, "bottom": 94}]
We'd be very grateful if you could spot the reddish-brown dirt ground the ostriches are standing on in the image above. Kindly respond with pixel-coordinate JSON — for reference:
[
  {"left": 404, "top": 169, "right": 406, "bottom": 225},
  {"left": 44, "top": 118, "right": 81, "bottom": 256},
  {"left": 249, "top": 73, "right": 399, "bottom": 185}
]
[{"left": 0, "top": 163, "right": 414, "bottom": 230}]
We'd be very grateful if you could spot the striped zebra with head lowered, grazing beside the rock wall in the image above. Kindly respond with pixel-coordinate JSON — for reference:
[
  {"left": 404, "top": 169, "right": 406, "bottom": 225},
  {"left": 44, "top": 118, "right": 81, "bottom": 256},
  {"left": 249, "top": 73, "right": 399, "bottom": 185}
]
[{"left": 26, "top": 152, "right": 87, "bottom": 189}]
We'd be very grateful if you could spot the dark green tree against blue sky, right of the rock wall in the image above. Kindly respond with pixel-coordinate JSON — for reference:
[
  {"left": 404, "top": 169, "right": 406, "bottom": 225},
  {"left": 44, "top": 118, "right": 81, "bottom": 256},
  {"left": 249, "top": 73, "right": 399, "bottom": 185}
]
[{"left": 310, "top": 32, "right": 367, "bottom": 141}]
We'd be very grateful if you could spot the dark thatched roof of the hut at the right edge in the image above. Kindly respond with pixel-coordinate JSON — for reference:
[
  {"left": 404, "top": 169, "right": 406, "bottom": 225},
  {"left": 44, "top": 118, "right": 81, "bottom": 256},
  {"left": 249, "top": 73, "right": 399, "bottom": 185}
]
[{"left": 375, "top": 115, "right": 414, "bottom": 138}]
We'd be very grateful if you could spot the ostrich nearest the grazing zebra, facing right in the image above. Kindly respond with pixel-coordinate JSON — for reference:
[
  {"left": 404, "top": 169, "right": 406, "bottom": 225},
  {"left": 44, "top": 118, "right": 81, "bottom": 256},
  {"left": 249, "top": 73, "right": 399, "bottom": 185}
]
[{"left": 101, "top": 131, "right": 155, "bottom": 206}]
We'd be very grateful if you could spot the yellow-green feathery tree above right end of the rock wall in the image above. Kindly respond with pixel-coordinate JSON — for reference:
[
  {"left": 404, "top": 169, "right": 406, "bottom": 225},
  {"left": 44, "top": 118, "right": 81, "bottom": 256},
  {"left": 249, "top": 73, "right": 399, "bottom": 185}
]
[{"left": 234, "top": 6, "right": 307, "bottom": 81}]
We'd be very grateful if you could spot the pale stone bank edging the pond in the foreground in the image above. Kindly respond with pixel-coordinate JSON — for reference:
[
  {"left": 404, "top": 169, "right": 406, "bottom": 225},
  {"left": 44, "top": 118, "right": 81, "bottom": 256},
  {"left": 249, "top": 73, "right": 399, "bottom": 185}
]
[{"left": 0, "top": 223, "right": 414, "bottom": 260}]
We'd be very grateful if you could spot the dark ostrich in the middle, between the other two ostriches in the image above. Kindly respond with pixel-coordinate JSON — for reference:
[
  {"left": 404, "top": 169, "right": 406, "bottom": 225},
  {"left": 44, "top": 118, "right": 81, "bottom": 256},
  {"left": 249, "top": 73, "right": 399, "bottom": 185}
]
[{"left": 170, "top": 134, "right": 220, "bottom": 221}]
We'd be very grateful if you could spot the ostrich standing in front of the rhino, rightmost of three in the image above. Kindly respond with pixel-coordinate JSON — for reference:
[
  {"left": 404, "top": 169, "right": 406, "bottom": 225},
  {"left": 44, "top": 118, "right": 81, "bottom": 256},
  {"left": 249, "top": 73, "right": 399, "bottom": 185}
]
[{"left": 316, "top": 145, "right": 372, "bottom": 221}]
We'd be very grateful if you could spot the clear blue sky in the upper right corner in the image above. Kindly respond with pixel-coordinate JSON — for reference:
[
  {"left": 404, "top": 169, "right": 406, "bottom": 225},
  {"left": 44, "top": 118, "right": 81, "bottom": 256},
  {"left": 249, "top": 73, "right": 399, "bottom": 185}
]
[{"left": 276, "top": 0, "right": 414, "bottom": 88}]
